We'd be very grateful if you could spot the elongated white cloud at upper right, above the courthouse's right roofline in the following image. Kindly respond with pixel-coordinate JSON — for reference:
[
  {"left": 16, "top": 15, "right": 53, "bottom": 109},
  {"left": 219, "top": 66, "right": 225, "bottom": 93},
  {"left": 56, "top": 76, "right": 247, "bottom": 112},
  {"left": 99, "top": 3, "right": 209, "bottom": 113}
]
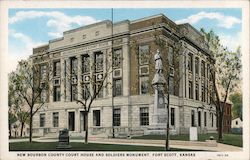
[{"left": 175, "top": 12, "right": 241, "bottom": 29}]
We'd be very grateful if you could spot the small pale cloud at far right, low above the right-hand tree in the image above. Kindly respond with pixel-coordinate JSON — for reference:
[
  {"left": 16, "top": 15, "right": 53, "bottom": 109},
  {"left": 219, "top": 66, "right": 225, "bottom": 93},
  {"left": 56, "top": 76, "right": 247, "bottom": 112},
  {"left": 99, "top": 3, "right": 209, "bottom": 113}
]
[{"left": 218, "top": 32, "right": 242, "bottom": 51}]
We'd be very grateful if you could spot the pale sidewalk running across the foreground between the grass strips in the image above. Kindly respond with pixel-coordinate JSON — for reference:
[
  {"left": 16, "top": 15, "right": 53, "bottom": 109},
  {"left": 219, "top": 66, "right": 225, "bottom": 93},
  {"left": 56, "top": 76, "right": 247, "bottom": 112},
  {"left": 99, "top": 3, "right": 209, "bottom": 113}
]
[{"left": 9, "top": 138, "right": 242, "bottom": 152}]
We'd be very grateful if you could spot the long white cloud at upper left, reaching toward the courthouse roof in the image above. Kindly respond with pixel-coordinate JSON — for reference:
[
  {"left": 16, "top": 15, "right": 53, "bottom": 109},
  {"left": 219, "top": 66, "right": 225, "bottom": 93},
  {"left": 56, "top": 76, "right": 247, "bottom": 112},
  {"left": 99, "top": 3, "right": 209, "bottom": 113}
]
[{"left": 9, "top": 11, "right": 100, "bottom": 38}]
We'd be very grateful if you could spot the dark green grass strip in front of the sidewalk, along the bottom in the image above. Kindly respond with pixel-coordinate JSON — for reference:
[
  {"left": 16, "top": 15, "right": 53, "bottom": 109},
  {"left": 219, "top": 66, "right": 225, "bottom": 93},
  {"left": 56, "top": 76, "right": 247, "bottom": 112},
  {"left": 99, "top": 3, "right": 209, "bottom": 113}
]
[{"left": 9, "top": 142, "right": 201, "bottom": 151}]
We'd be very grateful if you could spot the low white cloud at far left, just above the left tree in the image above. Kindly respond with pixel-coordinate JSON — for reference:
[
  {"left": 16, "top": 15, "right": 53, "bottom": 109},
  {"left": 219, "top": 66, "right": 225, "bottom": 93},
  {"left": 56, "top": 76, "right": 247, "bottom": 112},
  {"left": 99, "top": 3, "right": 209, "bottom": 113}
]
[{"left": 7, "top": 30, "right": 45, "bottom": 72}]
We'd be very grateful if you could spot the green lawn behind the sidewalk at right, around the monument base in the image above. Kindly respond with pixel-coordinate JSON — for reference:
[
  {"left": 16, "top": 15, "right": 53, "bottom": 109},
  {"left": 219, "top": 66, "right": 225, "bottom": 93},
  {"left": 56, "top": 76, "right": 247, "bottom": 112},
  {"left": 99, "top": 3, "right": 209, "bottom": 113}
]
[{"left": 133, "top": 133, "right": 243, "bottom": 147}]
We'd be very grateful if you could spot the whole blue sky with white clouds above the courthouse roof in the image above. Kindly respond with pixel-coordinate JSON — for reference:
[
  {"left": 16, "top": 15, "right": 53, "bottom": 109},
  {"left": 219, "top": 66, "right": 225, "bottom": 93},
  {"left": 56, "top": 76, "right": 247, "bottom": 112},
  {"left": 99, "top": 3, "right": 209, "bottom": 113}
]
[{"left": 7, "top": 8, "right": 242, "bottom": 72}]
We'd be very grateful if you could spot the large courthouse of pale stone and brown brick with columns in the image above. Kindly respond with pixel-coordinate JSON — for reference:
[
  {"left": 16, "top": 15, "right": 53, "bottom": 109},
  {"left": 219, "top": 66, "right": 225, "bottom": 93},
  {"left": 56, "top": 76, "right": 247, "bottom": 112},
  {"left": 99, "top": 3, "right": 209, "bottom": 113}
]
[{"left": 30, "top": 14, "right": 217, "bottom": 136}]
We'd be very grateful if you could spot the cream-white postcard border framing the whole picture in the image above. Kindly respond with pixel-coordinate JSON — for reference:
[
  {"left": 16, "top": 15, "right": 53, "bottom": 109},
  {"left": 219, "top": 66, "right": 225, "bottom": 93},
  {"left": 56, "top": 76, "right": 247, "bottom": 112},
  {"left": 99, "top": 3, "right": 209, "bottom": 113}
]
[{"left": 0, "top": 0, "right": 250, "bottom": 160}]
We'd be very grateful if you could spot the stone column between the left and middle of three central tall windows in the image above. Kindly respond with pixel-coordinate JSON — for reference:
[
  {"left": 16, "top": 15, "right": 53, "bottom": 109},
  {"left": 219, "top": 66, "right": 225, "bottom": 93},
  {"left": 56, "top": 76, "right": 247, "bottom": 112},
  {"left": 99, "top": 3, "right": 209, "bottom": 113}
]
[{"left": 76, "top": 55, "right": 82, "bottom": 100}]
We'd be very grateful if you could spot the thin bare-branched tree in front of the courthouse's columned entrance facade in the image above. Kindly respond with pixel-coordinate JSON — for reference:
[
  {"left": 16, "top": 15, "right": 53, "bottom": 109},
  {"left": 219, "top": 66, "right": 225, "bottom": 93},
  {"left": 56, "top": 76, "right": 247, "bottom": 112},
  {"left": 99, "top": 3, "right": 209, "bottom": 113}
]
[{"left": 66, "top": 49, "right": 117, "bottom": 144}]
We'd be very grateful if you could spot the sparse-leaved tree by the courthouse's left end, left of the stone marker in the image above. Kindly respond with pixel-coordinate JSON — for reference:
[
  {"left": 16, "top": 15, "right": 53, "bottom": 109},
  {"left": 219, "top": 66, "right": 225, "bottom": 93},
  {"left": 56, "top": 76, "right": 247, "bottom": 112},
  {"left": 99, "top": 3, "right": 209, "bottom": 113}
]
[{"left": 9, "top": 60, "right": 49, "bottom": 142}]
